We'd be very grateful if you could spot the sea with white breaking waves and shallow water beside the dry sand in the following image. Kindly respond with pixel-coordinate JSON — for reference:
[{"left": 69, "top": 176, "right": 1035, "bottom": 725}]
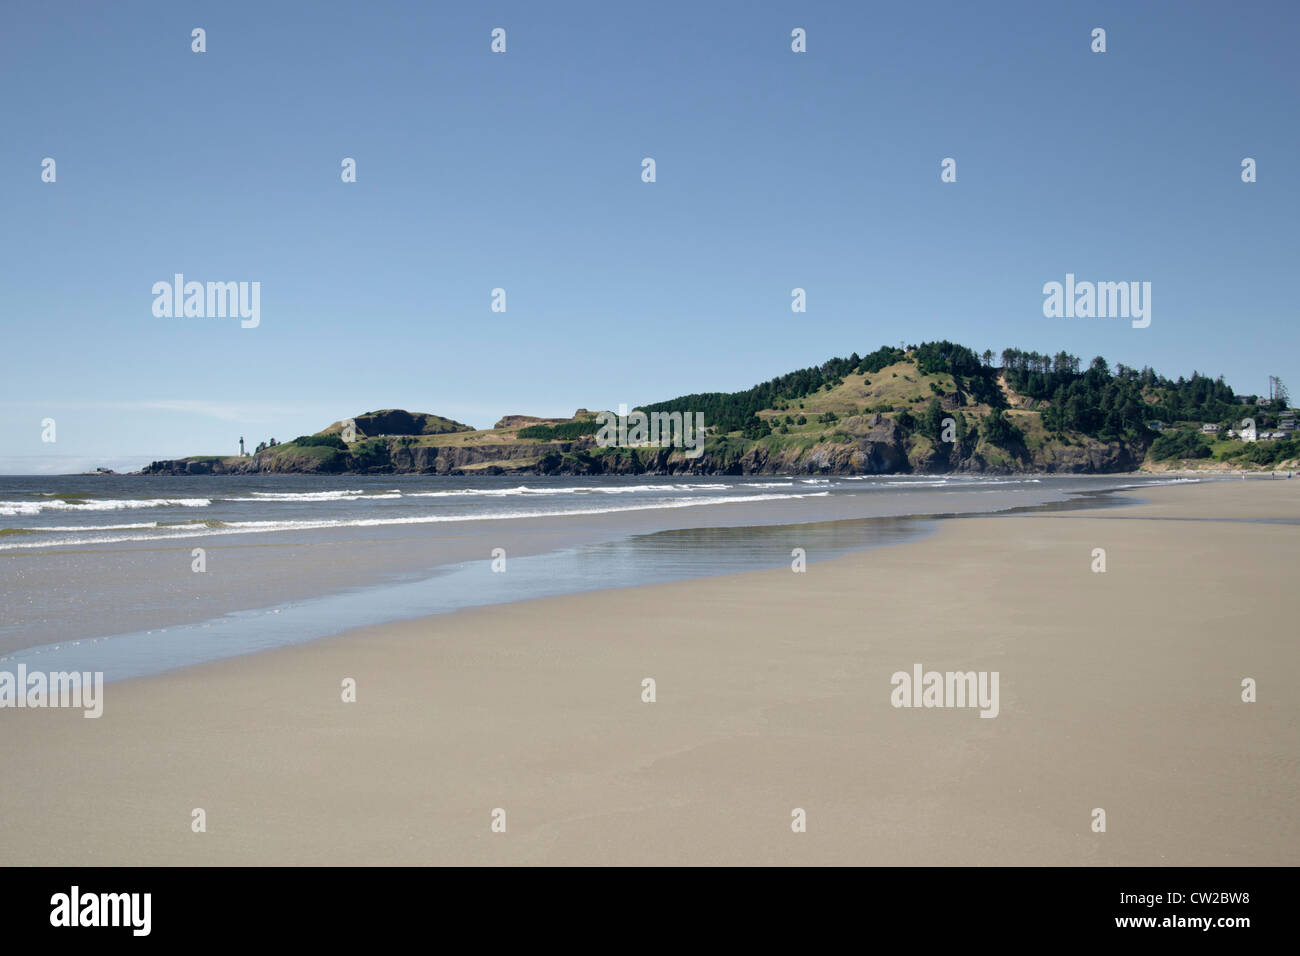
[{"left": 0, "top": 475, "right": 1188, "bottom": 680}]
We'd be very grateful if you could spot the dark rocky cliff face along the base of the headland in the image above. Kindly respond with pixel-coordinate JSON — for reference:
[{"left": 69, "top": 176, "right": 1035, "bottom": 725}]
[{"left": 142, "top": 429, "right": 1143, "bottom": 475}]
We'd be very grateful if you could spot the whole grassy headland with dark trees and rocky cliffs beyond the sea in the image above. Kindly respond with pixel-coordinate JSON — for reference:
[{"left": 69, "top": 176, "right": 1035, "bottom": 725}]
[{"left": 138, "top": 341, "right": 1300, "bottom": 476}]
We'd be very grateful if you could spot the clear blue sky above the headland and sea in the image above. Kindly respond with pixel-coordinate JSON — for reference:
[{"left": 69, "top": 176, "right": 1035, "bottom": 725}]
[{"left": 0, "top": 0, "right": 1300, "bottom": 473}]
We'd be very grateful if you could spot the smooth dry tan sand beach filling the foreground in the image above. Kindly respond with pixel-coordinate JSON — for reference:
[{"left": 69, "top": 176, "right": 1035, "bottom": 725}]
[{"left": 0, "top": 480, "right": 1300, "bottom": 865}]
